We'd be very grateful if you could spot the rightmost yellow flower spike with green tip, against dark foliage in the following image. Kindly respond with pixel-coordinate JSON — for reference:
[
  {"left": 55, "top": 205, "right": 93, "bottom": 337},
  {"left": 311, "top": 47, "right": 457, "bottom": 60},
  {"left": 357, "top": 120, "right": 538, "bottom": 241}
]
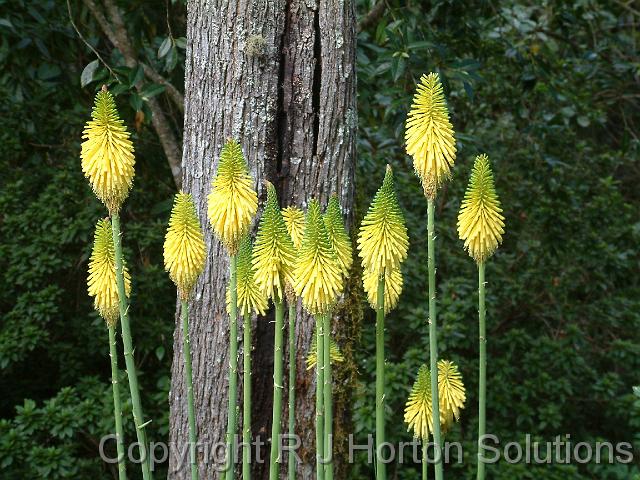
[{"left": 458, "top": 154, "right": 504, "bottom": 263}]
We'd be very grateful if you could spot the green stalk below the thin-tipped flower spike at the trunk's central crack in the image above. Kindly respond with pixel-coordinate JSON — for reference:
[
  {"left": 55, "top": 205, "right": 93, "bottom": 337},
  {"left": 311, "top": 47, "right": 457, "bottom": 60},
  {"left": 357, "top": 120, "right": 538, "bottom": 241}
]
[{"left": 269, "top": 300, "right": 284, "bottom": 480}]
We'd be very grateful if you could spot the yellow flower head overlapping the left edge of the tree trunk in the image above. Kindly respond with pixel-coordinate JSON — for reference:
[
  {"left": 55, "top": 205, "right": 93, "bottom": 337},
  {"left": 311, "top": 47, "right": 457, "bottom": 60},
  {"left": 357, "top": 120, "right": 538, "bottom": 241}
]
[{"left": 164, "top": 192, "right": 205, "bottom": 300}]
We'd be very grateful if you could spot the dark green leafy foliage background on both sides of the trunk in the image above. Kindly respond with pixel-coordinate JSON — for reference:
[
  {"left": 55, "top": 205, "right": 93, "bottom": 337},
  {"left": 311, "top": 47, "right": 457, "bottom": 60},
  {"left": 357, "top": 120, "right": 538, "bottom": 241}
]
[{"left": 0, "top": 0, "right": 640, "bottom": 480}]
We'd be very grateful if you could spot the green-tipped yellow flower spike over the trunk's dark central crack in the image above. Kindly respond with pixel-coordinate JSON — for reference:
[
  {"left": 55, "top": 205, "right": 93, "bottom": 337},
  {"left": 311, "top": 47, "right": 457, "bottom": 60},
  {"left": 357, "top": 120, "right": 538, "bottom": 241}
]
[{"left": 252, "top": 182, "right": 296, "bottom": 301}]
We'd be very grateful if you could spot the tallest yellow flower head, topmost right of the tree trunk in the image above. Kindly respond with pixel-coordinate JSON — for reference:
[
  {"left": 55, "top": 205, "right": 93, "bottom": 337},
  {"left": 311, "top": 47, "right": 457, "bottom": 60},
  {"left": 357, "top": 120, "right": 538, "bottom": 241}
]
[{"left": 405, "top": 73, "right": 456, "bottom": 198}]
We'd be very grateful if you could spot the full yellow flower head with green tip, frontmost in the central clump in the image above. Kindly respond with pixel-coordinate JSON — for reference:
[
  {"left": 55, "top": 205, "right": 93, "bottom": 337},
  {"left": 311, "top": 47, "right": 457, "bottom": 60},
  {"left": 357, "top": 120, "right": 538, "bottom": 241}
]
[{"left": 294, "top": 200, "right": 343, "bottom": 315}]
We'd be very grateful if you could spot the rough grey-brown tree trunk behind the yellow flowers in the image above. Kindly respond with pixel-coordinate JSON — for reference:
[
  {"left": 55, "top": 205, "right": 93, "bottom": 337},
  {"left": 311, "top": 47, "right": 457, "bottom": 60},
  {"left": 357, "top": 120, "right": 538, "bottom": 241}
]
[{"left": 169, "top": 0, "right": 357, "bottom": 479}]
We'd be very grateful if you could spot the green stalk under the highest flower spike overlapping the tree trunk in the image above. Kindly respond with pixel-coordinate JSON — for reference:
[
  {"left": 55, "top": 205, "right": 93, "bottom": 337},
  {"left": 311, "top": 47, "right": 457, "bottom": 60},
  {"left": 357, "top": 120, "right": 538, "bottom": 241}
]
[{"left": 225, "top": 255, "right": 238, "bottom": 480}]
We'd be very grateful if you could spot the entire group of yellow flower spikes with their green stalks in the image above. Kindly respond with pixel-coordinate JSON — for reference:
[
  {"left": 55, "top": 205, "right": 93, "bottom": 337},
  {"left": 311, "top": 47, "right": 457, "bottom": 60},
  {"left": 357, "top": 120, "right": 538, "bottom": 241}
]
[{"left": 81, "top": 73, "right": 504, "bottom": 480}]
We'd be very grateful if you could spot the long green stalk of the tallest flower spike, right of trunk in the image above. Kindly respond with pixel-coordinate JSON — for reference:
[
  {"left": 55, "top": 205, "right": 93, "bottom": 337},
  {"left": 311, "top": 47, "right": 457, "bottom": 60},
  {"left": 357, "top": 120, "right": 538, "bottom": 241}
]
[{"left": 427, "top": 199, "right": 444, "bottom": 480}]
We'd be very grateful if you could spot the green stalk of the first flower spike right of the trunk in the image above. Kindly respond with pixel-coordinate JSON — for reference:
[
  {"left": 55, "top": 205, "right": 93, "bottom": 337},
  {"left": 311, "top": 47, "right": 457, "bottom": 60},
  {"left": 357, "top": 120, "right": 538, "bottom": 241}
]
[{"left": 376, "top": 276, "right": 387, "bottom": 480}]
